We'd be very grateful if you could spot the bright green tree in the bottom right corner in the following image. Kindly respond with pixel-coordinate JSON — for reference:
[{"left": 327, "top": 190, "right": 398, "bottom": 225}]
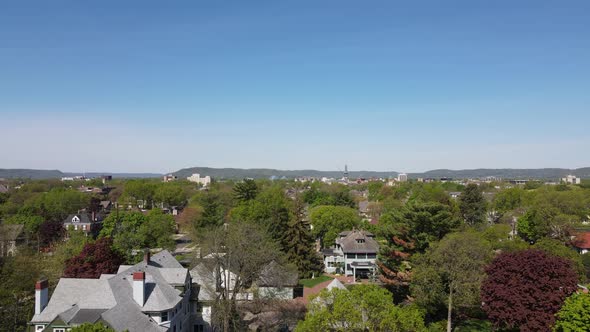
[{"left": 553, "top": 293, "right": 590, "bottom": 332}]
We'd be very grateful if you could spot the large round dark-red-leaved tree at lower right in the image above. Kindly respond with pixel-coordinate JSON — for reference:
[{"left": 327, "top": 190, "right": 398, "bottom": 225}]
[{"left": 481, "top": 250, "right": 578, "bottom": 331}]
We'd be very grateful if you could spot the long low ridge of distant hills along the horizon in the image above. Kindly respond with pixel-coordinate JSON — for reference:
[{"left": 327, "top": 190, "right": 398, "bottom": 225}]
[{"left": 0, "top": 167, "right": 590, "bottom": 180}]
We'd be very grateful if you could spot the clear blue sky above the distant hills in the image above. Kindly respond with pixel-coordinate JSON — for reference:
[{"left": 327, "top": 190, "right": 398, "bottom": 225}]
[{"left": 0, "top": 0, "right": 590, "bottom": 172}]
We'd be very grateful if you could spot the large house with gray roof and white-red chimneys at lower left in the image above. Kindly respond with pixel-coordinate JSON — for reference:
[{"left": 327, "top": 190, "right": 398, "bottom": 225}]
[{"left": 29, "top": 250, "right": 194, "bottom": 332}]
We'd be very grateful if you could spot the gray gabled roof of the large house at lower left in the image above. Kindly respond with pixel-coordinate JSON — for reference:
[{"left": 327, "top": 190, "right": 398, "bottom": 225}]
[{"left": 31, "top": 251, "right": 189, "bottom": 332}]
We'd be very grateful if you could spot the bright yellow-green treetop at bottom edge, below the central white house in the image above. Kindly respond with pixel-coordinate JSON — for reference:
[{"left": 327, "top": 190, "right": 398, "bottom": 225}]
[{"left": 295, "top": 285, "right": 426, "bottom": 332}]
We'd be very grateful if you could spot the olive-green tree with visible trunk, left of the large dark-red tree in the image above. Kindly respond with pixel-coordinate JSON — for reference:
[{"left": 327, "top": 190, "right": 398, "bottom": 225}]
[{"left": 411, "top": 232, "right": 493, "bottom": 332}]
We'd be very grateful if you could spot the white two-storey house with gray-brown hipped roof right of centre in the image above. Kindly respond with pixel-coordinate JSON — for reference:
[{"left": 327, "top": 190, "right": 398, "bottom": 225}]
[{"left": 322, "top": 230, "right": 379, "bottom": 278}]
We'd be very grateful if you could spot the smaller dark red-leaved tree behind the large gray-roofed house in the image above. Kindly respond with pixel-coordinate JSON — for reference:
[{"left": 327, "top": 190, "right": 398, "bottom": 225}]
[{"left": 64, "top": 237, "right": 124, "bottom": 278}]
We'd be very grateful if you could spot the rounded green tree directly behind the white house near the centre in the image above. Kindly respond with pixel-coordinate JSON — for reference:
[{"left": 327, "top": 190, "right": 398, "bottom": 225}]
[{"left": 310, "top": 205, "right": 361, "bottom": 247}]
